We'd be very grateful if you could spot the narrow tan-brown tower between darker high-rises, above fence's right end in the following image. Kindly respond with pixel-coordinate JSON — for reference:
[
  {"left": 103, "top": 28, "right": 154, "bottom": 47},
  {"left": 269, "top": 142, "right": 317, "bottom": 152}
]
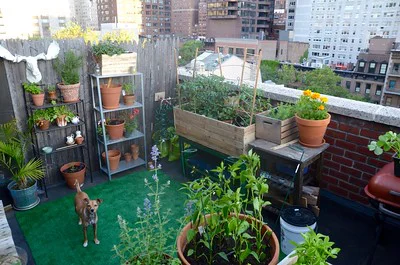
[{"left": 171, "top": 0, "right": 201, "bottom": 37}]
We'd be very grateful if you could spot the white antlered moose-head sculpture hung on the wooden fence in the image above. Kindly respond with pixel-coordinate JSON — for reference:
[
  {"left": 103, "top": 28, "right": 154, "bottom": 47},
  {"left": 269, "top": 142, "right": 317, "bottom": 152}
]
[{"left": 0, "top": 41, "right": 60, "bottom": 83}]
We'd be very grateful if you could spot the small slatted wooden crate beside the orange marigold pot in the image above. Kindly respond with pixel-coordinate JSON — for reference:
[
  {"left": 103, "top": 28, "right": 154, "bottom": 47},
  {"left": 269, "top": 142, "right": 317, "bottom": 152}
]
[{"left": 256, "top": 111, "right": 299, "bottom": 144}]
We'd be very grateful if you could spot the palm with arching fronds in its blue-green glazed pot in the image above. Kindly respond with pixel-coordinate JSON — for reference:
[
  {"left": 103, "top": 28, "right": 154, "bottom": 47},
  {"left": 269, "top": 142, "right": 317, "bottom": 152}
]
[{"left": 0, "top": 120, "right": 44, "bottom": 210}]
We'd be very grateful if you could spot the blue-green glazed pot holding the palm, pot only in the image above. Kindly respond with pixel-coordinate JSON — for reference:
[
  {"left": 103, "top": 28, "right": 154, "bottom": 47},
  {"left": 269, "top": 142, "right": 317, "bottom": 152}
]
[{"left": 7, "top": 178, "right": 40, "bottom": 211}]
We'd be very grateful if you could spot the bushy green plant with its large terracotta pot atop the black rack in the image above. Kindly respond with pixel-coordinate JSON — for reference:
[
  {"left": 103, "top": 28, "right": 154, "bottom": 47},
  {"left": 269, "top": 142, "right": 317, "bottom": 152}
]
[{"left": 54, "top": 50, "right": 83, "bottom": 102}]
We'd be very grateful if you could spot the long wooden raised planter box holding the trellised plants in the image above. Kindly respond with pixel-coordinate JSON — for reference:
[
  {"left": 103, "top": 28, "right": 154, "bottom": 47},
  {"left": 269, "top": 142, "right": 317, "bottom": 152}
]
[{"left": 174, "top": 107, "right": 256, "bottom": 156}]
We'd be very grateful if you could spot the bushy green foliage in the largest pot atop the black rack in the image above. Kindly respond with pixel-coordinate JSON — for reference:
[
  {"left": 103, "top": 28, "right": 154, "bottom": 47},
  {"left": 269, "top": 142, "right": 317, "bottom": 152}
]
[{"left": 53, "top": 50, "right": 83, "bottom": 85}]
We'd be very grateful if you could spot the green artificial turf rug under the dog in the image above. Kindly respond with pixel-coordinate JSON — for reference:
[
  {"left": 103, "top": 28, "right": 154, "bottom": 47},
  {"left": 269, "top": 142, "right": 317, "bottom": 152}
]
[{"left": 16, "top": 171, "right": 185, "bottom": 265}]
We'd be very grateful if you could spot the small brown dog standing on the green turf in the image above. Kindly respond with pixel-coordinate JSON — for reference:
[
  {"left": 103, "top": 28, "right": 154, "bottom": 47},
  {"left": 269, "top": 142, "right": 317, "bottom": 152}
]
[{"left": 75, "top": 180, "right": 103, "bottom": 247}]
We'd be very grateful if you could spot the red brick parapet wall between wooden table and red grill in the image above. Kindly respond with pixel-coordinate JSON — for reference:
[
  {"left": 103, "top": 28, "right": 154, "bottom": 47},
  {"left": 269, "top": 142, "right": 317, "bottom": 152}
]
[{"left": 321, "top": 114, "right": 399, "bottom": 204}]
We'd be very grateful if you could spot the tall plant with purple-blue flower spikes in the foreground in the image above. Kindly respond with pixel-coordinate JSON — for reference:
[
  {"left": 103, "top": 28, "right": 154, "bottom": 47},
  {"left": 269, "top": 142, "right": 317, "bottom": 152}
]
[{"left": 113, "top": 146, "right": 181, "bottom": 265}]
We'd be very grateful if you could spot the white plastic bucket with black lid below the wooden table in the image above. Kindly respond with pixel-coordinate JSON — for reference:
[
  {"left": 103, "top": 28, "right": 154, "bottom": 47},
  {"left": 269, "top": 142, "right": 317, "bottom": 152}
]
[{"left": 280, "top": 207, "right": 317, "bottom": 255}]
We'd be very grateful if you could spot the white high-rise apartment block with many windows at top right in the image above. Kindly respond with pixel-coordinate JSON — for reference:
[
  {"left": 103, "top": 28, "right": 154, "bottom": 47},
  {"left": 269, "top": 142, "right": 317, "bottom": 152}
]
[{"left": 288, "top": 0, "right": 400, "bottom": 66}]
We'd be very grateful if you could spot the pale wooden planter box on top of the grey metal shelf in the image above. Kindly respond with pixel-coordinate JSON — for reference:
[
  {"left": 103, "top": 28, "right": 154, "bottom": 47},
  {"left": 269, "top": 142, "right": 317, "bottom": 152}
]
[{"left": 98, "top": 52, "right": 137, "bottom": 75}]
